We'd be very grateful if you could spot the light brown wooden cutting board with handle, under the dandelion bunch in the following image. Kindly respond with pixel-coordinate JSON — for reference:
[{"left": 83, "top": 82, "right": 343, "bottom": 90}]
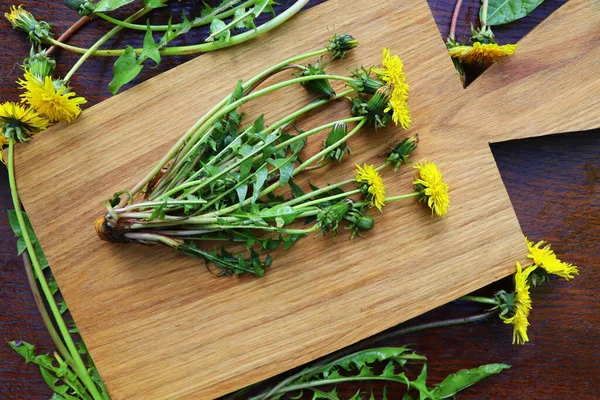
[{"left": 12, "top": 0, "right": 600, "bottom": 400}]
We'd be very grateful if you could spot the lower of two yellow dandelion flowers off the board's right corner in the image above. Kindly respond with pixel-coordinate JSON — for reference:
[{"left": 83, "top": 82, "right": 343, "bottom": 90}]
[{"left": 500, "top": 262, "right": 537, "bottom": 344}]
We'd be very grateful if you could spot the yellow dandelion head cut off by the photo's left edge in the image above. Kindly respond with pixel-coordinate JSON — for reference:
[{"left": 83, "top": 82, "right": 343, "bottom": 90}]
[{"left": 0, "top": 101, "right": 48, "bottom": 145}]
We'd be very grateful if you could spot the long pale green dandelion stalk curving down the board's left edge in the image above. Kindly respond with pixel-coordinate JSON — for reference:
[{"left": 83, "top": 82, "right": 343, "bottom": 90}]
[{"left": 8, "top": 138, "right": 103, "bottom": 400}]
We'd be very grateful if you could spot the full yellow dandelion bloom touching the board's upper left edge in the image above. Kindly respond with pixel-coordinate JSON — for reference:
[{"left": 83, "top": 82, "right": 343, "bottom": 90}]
[{"left": 17, "top": 70, "right": 87, "bottom": 122}]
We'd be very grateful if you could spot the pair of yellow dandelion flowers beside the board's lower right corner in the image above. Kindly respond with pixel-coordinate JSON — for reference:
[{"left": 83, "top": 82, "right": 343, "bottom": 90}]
[{"left": 500, "top": 238, "right": 579, "bottom": 344}]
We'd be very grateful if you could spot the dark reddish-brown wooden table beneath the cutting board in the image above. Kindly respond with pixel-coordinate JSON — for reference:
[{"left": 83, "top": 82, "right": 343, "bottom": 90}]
[{"left": 0, "top": 0, "right": 600, "bottom": 400}]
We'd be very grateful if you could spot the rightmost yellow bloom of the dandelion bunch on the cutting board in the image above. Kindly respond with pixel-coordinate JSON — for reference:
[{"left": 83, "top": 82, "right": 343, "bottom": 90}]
[{"left": 413, "top": 161, "right": 450, "bottom": 217}]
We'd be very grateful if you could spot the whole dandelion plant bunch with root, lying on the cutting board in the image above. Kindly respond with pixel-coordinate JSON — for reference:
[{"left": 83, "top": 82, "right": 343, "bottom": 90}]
[{"left": 96, "top": 35, "right": 448, "bottom": 275}]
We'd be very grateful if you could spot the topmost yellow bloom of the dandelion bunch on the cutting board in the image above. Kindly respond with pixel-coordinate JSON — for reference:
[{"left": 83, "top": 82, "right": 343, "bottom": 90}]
[{"left": 373, "top": 48, "right": 412, "bottom": 129}]
